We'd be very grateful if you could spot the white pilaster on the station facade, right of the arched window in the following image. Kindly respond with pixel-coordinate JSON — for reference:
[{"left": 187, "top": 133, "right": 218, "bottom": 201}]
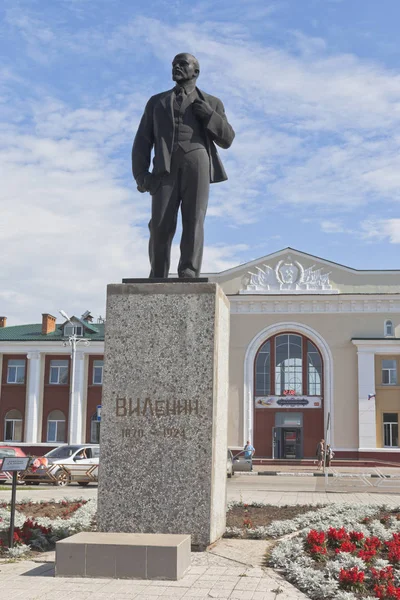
[{"left": 357, "top": 349, "right": 376, "bottom": 450}]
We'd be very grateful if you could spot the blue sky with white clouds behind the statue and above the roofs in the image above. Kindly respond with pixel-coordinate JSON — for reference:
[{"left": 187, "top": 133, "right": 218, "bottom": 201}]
[{"left": 0, "top": 0, "right": 400, "bottom": 324}]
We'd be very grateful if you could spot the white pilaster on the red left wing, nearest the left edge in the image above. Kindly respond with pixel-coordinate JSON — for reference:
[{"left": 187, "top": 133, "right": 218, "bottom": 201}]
[{"left": 25, "top": 352, "right": 41, "bottom": 444}]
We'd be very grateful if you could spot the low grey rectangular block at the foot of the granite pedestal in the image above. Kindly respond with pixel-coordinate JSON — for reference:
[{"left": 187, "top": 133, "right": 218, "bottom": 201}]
[{"left": 56, "top": 532, "right": 190, "bottom": 581}]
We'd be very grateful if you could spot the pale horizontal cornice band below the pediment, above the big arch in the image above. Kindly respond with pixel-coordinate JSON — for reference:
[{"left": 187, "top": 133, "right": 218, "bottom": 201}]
[{"left": 228, "top": 294, "right": 400, "bottom": 314}]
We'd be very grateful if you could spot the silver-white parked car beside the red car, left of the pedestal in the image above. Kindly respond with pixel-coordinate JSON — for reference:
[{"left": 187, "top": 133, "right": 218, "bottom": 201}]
[{"left": 24, "top": 444, "right": 100, "bottom": 486}]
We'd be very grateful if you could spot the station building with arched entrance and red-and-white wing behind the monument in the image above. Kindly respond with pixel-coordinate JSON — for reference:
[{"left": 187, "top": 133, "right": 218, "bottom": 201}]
[{"left": 0, "top": 248, "right": 400, "bottom": 462}]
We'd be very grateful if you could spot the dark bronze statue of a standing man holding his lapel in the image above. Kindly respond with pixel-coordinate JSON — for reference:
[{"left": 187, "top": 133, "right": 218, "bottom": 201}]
[{"left": 132, "top": 53, "right": 235, "bottom": 278}]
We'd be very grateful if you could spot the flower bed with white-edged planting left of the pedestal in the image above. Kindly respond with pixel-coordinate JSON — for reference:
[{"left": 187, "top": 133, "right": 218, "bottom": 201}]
[{"left": 0, "top": 498, "right": 97, "bottom": 557}]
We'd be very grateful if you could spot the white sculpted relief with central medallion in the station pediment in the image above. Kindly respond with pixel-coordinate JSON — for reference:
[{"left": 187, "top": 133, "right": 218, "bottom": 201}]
[{"left": 240, "top": 256, "right": 338, "bottom": 294}]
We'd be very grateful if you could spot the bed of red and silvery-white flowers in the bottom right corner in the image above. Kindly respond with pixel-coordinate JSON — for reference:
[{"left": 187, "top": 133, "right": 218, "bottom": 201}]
[{"left": 267, "top": 505, "right": 400, "bottom": 600}]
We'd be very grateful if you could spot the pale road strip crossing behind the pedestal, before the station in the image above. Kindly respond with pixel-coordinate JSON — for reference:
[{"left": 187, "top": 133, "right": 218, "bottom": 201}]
[{"left": 0, "top": 474, "right": 400, "bottom": 505}]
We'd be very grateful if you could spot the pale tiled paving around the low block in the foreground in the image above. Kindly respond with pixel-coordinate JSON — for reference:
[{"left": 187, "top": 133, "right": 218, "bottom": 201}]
[{"left": 0, "top": 540, "right": 307, "bottom": 600}]
